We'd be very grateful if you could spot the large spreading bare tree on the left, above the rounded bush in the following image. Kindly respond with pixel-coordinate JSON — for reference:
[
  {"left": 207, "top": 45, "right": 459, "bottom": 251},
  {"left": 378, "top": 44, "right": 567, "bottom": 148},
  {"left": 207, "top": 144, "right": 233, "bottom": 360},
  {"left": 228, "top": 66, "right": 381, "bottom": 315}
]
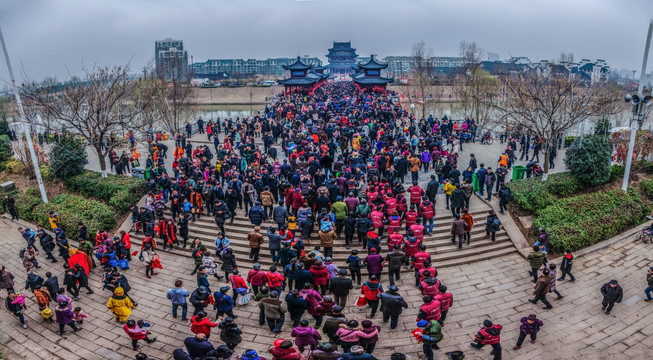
[{"left": 21, "top": 65, "right": 147, "bottom": 177}]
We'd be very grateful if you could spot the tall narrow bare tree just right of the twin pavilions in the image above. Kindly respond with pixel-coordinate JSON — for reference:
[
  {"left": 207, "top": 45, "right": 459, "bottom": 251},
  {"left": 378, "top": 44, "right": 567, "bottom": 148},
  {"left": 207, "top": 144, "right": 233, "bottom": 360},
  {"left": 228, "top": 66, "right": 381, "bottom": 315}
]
[{"left": 411, "top": 40, "right": 435, "bottom": 117}]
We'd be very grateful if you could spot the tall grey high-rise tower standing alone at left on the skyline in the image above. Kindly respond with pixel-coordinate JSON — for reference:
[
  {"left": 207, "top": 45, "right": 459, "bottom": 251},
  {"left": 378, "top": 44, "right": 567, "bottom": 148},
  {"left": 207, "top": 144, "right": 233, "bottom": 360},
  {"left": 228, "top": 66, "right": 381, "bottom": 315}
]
[{"left": 154, "top": 38, "right": 191, "bottom": 79}]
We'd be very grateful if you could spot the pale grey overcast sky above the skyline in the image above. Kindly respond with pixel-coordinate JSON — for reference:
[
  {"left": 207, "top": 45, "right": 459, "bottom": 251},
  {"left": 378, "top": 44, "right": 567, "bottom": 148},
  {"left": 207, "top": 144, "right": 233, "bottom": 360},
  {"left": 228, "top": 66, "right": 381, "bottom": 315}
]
[{"left": 0, "top": 0, "right": 653, "bottom": 83}]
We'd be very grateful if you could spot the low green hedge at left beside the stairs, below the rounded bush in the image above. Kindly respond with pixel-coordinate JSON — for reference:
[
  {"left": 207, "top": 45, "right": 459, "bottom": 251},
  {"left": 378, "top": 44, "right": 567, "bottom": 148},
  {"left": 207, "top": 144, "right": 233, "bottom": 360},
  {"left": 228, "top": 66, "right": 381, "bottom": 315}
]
[{"left": 66, "top": 171, "right": 146, "bottom": 214}]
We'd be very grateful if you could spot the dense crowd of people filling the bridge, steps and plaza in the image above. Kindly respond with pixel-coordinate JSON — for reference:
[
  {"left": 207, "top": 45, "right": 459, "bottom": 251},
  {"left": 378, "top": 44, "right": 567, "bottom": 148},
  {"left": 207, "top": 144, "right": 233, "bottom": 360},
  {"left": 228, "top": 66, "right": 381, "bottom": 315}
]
[{"left": 0, "top": 82, "right": 644, "bottom": 360}]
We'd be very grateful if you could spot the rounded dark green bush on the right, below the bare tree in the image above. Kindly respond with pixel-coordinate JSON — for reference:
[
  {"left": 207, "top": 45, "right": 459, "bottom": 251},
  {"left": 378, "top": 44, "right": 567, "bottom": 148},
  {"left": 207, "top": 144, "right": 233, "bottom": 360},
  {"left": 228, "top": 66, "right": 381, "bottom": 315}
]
[{"left": 565, "top": 135, "right": 612, "bottom": 186}]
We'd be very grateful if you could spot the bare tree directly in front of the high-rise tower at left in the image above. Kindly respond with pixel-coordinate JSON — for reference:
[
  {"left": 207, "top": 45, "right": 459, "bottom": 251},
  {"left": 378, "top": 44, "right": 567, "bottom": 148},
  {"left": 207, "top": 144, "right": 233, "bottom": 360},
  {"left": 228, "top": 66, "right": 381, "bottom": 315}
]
[{"left": 155, "top": 58, "right": 195, "bottom": 134}]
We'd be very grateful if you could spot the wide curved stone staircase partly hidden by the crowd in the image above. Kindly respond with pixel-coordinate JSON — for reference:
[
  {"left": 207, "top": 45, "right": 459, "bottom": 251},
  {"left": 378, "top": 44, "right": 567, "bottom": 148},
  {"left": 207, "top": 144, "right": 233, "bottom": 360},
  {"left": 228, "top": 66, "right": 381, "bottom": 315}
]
[{"left": 131, "top": 195, "right": 517, "bottom": 271}]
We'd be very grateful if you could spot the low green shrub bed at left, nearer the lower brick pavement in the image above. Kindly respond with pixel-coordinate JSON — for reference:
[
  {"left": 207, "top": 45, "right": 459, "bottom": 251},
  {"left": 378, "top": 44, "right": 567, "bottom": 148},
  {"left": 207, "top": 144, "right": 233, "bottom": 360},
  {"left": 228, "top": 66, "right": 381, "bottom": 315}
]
[{"left": 34, "top": 194, "right": 116, "bottom": 238}]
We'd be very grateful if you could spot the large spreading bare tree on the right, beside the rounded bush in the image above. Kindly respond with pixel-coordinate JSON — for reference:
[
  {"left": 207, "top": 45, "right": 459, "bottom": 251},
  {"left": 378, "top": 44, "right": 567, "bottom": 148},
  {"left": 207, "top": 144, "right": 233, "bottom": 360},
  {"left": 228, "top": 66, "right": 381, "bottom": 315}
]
[{"left": 494, "top": 66, "right": 623, "bottom": 180}]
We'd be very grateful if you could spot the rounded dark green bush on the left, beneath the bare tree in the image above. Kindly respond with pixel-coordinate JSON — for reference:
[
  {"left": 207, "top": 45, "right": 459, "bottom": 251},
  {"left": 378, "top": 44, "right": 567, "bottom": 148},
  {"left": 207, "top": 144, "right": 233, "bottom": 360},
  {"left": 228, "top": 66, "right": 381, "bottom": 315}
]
[{"left": 50, "top": 136, "right": 87, "bottom": 179}]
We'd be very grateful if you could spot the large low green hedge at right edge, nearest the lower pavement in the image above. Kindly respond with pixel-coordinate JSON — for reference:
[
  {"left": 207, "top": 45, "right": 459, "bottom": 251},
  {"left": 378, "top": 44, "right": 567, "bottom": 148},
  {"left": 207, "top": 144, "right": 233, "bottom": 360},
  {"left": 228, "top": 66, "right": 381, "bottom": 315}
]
[{"left": 533, "top": 189, "right": 651, "bottom": 252}]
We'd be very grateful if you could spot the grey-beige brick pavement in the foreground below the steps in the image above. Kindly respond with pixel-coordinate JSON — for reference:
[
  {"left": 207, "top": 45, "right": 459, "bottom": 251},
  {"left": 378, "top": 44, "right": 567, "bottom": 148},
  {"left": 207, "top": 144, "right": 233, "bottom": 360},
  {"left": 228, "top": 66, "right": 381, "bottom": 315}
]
[{"left": 0, "top": 210, "right": 653, "bottom": 360}]
